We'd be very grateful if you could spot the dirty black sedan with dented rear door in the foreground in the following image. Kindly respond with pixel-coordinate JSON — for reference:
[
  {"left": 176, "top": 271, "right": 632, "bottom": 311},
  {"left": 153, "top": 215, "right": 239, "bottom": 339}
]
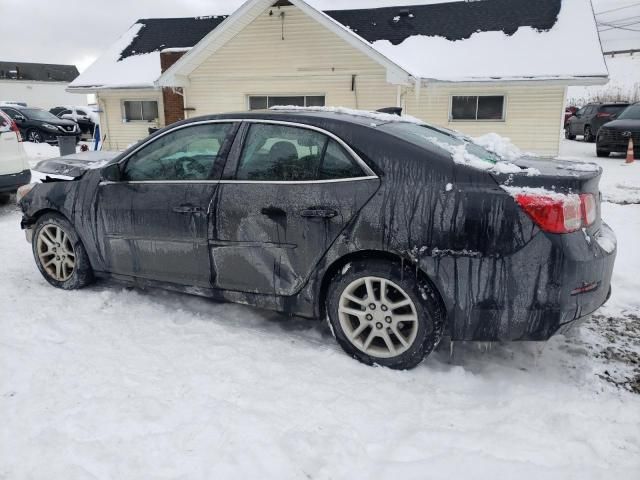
[{"left": 13, "top": 109, "right": 616, "bottom": 369}]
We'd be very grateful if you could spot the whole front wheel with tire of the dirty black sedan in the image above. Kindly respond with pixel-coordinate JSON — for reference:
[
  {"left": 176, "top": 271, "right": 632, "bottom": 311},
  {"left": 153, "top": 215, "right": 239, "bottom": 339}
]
[{"left": 31, "top": 213, "right": 93, "bottom": 290}]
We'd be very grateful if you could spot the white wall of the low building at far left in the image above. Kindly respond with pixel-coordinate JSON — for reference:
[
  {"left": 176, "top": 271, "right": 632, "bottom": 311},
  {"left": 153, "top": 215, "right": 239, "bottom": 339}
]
[{"left": 0, "top": 80, "right": 87, "bottom": 110}]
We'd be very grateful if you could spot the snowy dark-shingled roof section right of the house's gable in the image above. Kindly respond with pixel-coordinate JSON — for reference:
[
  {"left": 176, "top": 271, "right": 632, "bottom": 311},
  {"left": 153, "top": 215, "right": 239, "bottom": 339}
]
[{"left": 322, "top": 0, "right": 607, "bottom": 81}]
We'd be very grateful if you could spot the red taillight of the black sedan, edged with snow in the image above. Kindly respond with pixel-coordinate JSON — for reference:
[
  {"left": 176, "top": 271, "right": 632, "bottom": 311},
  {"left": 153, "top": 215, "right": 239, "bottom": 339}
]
[{"left": 515, "top": 193, "right": 597, "bottom": 233}]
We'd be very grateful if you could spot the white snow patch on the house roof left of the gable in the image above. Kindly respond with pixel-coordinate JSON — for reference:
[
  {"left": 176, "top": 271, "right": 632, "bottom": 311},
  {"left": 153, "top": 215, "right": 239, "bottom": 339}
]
[{"left": 69, "top": 23, "right": 161, "bottom": 89}]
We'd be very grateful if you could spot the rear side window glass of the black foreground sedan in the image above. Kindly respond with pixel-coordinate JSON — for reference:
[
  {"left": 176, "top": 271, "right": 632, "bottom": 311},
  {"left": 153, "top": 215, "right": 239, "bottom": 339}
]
[{"left": 236, "top": 124, "right": 363, "bottom": 182}]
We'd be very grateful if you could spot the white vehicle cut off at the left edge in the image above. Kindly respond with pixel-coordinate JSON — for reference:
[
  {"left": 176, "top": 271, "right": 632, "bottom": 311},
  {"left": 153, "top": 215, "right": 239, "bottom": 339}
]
[{"left": 0, "top": 111, "right": 31, "bottom": 203}]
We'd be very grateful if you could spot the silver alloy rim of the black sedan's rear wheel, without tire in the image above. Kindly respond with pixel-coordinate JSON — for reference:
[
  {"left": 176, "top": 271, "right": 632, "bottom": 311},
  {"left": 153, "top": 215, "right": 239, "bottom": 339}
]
[{"left": 338, "top": 277, "right": 418, "bottom": 358}]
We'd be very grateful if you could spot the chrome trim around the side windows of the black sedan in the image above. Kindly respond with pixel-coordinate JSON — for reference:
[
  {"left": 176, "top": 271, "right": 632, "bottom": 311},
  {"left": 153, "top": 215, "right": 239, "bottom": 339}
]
[{"left": 112, "top": 118, "right": 379, "bottom": 185}]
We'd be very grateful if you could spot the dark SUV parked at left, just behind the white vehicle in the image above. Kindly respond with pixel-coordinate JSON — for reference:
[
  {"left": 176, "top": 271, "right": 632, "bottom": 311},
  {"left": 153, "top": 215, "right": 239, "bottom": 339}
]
[{"left": 0, "top": 105, "right": 80, "bottom": 144}]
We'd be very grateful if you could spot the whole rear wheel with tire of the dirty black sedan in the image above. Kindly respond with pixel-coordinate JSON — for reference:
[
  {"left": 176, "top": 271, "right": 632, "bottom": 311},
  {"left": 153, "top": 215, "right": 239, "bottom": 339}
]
[{"left": 325, "top": 260, "right": 444, "bottom": 370}]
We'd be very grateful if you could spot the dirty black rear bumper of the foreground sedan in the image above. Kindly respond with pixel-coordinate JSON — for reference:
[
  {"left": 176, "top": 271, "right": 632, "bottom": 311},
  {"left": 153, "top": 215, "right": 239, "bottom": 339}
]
[{"left": 422, "top": 224, "right": 616, "bottom": 342}]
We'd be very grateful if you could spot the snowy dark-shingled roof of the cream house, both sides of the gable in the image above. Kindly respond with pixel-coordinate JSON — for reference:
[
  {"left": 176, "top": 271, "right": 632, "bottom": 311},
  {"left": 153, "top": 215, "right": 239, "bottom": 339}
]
[{"left": 70, "top": 0, "right": 607, "bottom": 90}]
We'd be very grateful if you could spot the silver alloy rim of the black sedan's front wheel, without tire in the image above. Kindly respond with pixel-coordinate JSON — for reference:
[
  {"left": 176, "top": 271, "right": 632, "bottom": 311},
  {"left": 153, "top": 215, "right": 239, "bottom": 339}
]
[{"left": 36, "top": 224, "right": 76, "bottom": 282}]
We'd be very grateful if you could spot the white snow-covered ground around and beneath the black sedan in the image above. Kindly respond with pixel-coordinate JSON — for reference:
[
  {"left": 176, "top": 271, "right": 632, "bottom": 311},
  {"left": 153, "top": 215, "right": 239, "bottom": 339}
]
[{"left": 0, "top": 138, "right": 640, "bottom": 480}]
